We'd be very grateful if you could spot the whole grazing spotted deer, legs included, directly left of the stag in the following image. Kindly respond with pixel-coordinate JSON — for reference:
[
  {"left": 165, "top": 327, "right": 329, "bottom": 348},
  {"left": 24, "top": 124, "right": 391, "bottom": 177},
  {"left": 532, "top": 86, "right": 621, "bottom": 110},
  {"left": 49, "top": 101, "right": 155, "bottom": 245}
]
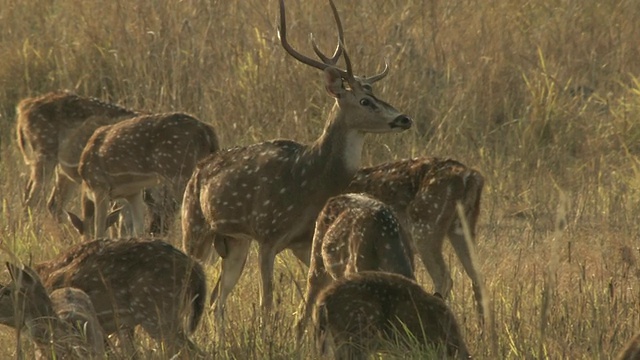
[{"left": 69, "top": 113, "right": 219, "bottom": 238}]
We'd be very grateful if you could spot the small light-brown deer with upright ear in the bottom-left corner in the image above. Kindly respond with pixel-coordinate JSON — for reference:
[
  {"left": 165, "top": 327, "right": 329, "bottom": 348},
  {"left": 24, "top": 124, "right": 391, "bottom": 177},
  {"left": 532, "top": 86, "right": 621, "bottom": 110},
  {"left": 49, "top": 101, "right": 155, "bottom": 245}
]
[{"left": 0, "top": 263, "right": 106, "bottom": 359}]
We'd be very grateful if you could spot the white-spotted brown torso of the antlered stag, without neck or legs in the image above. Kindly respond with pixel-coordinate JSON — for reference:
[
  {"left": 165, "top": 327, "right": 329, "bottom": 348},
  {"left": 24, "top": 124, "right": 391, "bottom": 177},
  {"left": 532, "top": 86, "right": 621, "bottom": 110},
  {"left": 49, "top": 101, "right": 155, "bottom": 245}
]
[{"left": 183, "top": 140, "right": 348, "bottom": 252}]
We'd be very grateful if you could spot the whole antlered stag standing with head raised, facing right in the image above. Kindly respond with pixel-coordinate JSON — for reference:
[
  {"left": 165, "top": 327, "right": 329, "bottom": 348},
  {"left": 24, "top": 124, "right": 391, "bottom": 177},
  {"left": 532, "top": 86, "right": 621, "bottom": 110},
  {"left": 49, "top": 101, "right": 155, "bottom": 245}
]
[{"left": 182, "top": 0, "right": 412, "bottom": 318}]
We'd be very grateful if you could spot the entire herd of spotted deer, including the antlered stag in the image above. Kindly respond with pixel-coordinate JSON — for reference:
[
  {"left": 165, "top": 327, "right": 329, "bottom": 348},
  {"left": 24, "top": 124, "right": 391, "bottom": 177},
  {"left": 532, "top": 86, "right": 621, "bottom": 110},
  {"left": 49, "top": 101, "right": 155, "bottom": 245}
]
[{"left": 0, "top": 0, "right": 636, "bottom": 359}]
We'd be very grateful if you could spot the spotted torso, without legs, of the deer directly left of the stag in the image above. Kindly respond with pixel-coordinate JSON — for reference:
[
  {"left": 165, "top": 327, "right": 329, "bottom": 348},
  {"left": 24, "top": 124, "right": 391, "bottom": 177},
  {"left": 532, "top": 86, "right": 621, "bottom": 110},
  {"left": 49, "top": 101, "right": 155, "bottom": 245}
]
[{"left": 78, "top": 113, "right": 219, "bottom": 195}]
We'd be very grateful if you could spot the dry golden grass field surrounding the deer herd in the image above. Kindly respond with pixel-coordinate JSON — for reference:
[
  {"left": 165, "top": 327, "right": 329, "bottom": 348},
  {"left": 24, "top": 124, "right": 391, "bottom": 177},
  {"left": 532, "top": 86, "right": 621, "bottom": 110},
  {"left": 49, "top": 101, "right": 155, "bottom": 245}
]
[{"left": 0, "top": 0, "right": 640, "bottom": 359}]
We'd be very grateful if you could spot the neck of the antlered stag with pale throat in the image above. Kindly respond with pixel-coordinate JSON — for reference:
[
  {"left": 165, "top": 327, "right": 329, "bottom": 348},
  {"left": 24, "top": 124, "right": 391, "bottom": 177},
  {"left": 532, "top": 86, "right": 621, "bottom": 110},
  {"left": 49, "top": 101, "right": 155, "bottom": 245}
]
[{"left": 310, "top": 104, "right": 365, "bottom": 186}]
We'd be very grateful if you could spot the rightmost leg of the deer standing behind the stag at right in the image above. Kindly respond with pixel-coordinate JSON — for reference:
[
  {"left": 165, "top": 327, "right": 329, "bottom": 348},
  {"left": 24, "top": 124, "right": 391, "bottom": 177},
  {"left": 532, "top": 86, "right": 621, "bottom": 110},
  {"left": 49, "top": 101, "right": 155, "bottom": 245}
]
[{"left": 449, "top": 220, "right": 484, "bottom": 321}]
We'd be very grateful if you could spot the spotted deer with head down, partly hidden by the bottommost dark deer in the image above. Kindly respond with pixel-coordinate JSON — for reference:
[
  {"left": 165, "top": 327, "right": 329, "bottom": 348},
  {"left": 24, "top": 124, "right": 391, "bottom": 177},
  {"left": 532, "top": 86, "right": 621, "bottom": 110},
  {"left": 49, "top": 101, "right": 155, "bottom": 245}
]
[{"left": 296, "top": 194, "right": 415, "bottom": 339}]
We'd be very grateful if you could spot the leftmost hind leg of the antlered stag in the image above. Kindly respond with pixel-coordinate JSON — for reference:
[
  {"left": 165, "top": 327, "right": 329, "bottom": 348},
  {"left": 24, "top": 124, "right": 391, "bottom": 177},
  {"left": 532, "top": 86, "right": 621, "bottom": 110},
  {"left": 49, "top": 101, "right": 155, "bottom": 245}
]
[{"left": 211, "top": 237, "right": 251, "bottom": 321}]
